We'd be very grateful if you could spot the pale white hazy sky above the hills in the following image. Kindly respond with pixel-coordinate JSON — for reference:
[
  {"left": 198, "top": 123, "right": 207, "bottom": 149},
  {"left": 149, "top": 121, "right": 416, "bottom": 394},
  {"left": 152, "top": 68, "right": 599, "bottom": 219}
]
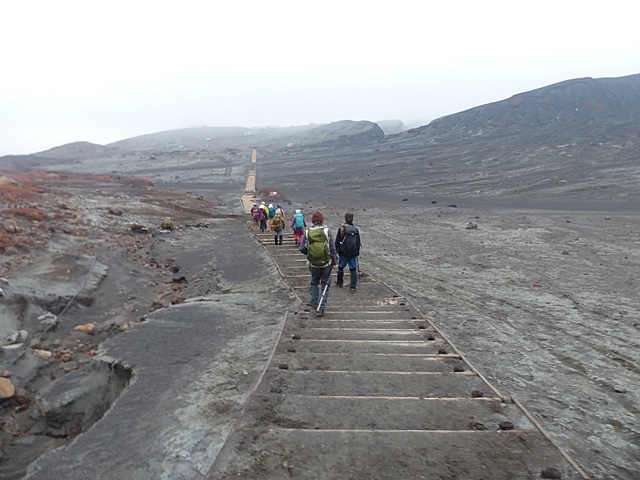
[{"left": 0, "top": 0, "right": 640, "bottom": 155}]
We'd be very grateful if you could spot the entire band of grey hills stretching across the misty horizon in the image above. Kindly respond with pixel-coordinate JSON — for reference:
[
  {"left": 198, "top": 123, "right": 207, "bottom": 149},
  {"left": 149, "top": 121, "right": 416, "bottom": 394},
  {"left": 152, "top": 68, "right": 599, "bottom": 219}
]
[{"left": 1, "top": 74, "right": 640, "bottom": 207}]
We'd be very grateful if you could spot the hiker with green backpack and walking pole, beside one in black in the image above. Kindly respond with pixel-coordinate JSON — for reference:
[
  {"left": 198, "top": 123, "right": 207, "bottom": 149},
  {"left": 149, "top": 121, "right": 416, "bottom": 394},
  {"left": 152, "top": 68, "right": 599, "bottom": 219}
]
[{"left": 298, "top": 212, "right": 338, "bottom": 317}]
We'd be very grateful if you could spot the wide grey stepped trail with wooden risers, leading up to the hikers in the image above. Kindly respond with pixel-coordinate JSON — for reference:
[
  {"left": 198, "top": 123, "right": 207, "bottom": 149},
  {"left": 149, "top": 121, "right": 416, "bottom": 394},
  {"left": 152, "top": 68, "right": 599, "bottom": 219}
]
[{"left": 208, "top": 226, "right": 586, "bottom": 480}]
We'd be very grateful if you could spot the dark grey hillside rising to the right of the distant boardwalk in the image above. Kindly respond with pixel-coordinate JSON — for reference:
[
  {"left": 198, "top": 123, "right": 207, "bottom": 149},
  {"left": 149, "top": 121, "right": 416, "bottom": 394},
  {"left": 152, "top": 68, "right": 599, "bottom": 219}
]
[{"left": 261, "top": 75, "right": 640, "bottom": 204}]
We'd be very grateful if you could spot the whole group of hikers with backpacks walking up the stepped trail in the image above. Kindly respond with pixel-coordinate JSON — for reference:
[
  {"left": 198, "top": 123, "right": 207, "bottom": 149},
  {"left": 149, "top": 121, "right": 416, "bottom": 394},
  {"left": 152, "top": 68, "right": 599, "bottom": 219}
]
[{"left": 251, "top": 202, "right": 361, "bottom": 317}]
